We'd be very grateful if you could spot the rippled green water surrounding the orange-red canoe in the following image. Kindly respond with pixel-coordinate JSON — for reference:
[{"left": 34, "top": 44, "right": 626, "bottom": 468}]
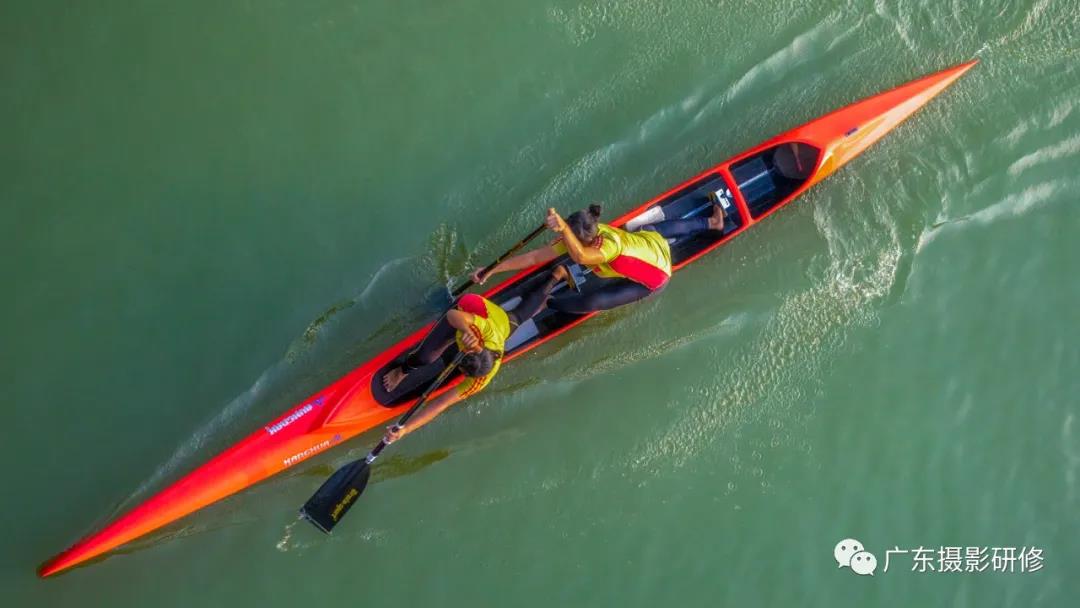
[{"left": 0, "top": 0, "right": 1080, "bottom": 607}]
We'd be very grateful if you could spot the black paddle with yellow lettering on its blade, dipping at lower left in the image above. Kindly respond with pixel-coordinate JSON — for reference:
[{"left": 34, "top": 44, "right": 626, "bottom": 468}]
[{"left": 300, "top": 352, "right": 465, "bottom": 533}]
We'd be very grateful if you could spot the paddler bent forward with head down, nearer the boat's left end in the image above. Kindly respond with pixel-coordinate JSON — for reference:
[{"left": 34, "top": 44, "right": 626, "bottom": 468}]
[{"left": 382, "top": 294, "right": 518, "bottom": 443}]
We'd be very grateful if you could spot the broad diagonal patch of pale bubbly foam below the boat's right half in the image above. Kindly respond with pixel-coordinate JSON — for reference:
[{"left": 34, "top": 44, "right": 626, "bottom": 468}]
[{"left": 626, "top": 195, "right": 909, "bottom": 475}]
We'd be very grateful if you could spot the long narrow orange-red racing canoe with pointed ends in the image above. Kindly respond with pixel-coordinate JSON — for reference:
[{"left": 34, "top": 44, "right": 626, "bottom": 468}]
[{"left": 38, "top": 62, "right": 975, "bottom": 577}]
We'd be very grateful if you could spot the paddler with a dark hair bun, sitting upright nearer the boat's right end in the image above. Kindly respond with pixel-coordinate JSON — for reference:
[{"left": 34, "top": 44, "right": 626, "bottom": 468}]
[{"left": 473, "top": 205, "right": 725, "bottom": 321}]
